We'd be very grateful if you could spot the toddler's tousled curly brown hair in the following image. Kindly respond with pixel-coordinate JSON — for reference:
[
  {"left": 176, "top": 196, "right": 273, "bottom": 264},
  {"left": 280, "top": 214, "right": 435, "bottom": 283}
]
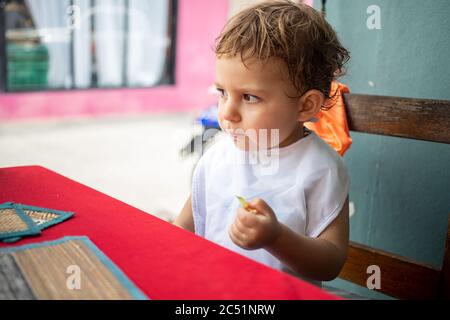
[{"left": 214, "top": 0, "right": 350, "bottom": 105}]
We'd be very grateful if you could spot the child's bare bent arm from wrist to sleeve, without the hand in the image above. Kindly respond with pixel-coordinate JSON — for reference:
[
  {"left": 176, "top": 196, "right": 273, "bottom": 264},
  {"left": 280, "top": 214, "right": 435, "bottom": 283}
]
[{"left": 265, "top": 197, "right": 349, "bottom": 281}]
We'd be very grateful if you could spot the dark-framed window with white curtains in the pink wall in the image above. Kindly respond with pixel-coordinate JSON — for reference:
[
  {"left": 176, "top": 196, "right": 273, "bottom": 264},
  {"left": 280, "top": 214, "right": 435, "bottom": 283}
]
[{"left": 0, "top": 0, "right": 177, "bottom": 91}]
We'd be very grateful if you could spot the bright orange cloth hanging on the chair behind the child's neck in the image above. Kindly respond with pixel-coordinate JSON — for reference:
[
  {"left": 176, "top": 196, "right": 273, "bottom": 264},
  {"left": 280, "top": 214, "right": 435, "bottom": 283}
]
[{"left": 304, "top": 81, "right": 352, "bottom": 156}]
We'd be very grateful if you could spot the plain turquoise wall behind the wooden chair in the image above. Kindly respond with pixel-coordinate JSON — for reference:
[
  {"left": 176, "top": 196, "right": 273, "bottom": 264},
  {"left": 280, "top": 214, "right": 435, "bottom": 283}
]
[{"left": 315, "top": 0, "right": 450, "bottom": 297}]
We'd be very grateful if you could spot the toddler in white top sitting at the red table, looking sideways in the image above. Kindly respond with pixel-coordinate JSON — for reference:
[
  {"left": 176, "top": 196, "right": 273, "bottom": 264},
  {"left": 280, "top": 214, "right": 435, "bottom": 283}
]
[{"left": 175, "top": 1, "right": 349, "bottom": 284}]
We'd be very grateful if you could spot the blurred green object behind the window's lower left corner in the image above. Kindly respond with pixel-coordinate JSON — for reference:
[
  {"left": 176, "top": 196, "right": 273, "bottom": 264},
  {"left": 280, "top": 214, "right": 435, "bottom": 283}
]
[{"left": 7, "top": 43, "right": 49, "bottom": 91}]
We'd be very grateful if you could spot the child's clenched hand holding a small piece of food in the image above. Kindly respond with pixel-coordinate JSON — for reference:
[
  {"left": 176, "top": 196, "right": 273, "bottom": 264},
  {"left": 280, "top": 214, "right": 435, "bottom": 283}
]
[{"left": 228, "top": 198, "right": 281, "bottom": 250}]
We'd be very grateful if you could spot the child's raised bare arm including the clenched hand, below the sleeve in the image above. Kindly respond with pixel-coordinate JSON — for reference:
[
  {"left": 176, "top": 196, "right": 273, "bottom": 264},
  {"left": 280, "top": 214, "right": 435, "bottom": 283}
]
[{"left": 229, "top": 197, "right": 349, "bottom": 281}]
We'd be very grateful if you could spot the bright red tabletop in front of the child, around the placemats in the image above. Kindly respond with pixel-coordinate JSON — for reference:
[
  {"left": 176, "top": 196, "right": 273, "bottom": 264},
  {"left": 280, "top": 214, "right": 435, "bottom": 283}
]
[{"left": 0, "top": 166, "right": 336, "bottom": 300}]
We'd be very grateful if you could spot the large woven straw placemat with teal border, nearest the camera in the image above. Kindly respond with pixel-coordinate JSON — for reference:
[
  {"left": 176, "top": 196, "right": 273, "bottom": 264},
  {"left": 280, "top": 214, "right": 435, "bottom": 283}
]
[{"left": 0, "top": 237, "right": 147, "bottom": 300}]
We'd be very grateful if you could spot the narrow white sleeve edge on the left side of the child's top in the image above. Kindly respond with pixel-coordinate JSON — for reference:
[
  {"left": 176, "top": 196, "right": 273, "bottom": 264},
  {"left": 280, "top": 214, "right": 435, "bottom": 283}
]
[{"left": 192, "top": 156, "right": 206, "bottom": 237}]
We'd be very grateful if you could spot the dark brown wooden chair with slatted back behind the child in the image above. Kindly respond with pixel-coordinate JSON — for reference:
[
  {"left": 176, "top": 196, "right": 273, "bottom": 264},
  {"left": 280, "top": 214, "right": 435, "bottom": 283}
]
[{"left": 339, "top": 94, "right": 450, "bottom": 299}]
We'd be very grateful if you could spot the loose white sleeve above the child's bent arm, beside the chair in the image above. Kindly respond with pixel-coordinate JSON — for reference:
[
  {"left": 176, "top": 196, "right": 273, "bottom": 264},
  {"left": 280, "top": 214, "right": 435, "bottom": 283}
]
[{"left": 305, "top": 159, "right": 350, "bottom": 238}]
